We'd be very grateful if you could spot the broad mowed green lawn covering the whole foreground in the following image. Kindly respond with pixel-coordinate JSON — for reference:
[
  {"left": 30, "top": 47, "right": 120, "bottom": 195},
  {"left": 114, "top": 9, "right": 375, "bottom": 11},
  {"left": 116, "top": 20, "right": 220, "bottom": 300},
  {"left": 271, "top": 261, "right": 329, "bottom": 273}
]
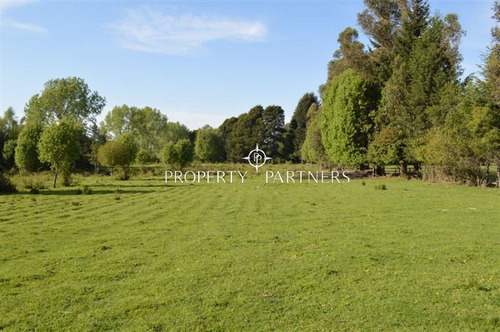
[{"left": 0, "top": 172, "right": 500, "bottom": 331}]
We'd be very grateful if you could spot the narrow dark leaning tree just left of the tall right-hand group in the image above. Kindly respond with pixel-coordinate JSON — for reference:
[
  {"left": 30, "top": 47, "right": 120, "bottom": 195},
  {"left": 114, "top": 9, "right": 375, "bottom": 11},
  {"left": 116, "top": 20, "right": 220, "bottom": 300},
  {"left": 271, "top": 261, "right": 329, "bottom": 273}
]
[{"left": 283, "top": 92, "right": 319, "bottom": 161}]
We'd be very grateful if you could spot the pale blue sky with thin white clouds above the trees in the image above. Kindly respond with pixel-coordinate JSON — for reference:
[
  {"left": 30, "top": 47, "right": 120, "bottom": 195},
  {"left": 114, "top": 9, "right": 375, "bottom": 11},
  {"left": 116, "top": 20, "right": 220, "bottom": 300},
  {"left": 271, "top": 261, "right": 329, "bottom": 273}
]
[{"left": 0, "top": 0, "right": 494, "bottom": 129}]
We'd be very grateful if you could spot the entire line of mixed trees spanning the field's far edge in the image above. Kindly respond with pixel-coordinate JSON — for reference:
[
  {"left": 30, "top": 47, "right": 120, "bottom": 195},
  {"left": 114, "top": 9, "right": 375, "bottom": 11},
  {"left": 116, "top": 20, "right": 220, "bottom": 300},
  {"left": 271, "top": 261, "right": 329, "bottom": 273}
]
[{"left": 0, "top": 0, "right": 500, "bottom": 191}]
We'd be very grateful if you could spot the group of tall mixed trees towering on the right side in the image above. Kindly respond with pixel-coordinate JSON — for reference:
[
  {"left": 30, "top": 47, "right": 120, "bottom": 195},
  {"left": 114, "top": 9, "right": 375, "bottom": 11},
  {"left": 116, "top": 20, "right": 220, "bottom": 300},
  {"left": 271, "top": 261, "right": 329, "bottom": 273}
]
[{"left": 302, "top": 0, "right": 500, "bottom": 186}]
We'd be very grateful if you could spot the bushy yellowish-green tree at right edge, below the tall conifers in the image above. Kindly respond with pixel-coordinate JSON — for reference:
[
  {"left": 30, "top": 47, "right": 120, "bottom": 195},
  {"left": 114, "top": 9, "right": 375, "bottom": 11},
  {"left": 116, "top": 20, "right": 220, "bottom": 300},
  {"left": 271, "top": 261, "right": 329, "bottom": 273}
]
[{"left": 419, "top": 78, "right": 500, "bottom": 186}]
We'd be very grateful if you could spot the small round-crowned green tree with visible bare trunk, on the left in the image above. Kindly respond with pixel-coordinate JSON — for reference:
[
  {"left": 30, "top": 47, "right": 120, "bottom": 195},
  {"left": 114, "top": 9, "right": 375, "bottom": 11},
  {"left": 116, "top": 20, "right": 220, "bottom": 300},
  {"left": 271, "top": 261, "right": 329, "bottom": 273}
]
[{"left": 38, "top": 118, "right": 83, "bottom": 188}]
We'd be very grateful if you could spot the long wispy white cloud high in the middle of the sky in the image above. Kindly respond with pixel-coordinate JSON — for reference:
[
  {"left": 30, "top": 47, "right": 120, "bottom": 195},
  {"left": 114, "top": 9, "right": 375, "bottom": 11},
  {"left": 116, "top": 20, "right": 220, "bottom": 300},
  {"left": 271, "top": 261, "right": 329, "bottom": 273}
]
[{"left": 110, "top": 8, "right": 267, "bottom": 54}]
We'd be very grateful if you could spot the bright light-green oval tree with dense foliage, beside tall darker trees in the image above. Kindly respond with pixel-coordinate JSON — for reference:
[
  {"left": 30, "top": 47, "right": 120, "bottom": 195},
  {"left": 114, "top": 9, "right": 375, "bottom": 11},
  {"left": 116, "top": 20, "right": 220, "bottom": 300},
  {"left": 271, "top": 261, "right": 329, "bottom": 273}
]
[{"left": 321, "top": 69, "right": 374, "bottom": 166}]
